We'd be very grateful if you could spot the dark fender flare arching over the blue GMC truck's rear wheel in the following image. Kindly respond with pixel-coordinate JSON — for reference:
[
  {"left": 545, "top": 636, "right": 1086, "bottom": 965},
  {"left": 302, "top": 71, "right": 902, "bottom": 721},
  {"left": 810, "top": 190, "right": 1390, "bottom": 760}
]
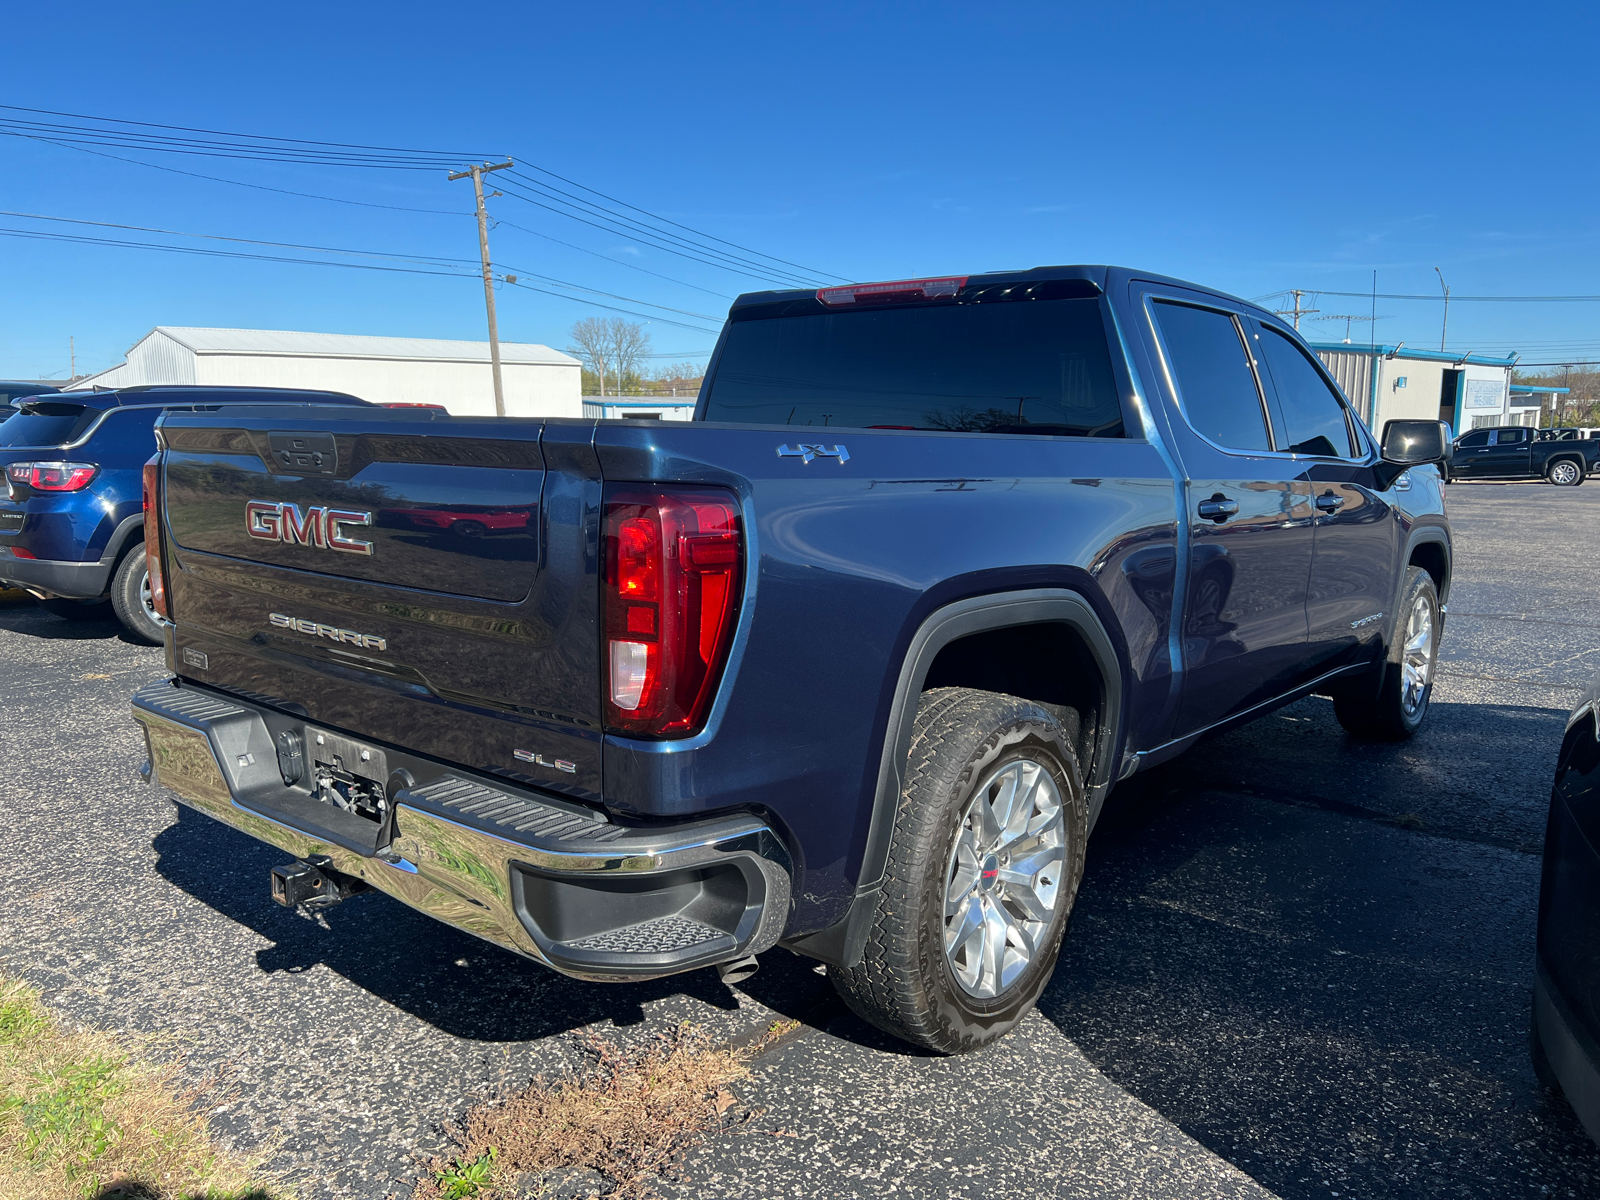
[{"left": 784, "top": 587, "right": 1125, "bottom": 966}]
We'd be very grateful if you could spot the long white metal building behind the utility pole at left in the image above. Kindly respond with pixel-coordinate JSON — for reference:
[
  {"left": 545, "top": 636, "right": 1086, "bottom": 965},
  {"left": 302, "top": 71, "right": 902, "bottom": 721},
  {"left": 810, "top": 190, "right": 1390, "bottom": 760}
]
[{"left": 69, "top": 325, "right": 584, "bottom": 416}]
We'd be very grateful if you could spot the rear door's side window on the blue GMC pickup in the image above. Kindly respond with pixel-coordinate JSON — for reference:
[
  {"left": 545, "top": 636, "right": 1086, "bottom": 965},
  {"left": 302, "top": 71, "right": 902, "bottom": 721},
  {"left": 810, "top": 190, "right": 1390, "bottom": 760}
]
[{"left": 1155, "top": 301, "right": 1272, "bottom": 450}]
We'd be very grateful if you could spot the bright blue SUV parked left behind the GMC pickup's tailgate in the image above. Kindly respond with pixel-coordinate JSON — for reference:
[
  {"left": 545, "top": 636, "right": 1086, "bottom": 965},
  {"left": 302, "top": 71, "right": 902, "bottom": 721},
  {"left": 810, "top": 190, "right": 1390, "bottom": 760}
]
[{"left": 0, "top": 387, "right": 366, "bottom": 645}]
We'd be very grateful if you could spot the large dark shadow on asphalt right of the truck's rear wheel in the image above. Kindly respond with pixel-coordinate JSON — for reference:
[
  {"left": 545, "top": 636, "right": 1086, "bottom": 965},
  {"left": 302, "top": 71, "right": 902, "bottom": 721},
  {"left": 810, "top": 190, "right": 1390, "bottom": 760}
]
[{"left": 1040, "top": 701, "right": 1600, "bottom": 1197}]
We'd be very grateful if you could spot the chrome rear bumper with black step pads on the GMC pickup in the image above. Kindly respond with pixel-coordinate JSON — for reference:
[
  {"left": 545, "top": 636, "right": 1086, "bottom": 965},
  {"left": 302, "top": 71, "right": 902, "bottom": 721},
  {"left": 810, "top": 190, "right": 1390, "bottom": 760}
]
[{"left": 133, "top": 680, "right": 790, "bottom": 979}]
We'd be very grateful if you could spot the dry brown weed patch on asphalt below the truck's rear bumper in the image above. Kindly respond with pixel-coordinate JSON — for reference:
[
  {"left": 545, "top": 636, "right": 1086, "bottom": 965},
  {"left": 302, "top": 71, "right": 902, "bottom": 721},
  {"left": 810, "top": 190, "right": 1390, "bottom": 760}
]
[{"left": 413, "top": 1026, "right": 771, "bottom": 1200}]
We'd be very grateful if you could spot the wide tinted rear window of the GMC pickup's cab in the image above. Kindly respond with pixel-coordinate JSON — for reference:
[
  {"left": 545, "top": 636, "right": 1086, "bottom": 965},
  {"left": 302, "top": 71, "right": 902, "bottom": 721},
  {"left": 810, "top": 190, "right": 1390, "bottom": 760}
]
[{"left": 706, "top": 293, "right": 1123, "bottom": 437}]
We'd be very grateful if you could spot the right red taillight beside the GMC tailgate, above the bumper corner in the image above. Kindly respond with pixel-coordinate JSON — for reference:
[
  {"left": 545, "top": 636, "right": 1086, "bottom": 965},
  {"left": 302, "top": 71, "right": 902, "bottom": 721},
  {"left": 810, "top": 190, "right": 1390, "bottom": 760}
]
[{"left": 605, "top": 485, "right": 742, "bottom": 738}]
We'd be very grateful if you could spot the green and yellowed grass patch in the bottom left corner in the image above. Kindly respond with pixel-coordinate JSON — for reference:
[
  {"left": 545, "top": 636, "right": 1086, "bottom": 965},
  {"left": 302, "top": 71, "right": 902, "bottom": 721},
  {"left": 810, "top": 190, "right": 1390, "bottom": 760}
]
[{"left": 0, "top": 976, "right": 291, "bottom": 1200}]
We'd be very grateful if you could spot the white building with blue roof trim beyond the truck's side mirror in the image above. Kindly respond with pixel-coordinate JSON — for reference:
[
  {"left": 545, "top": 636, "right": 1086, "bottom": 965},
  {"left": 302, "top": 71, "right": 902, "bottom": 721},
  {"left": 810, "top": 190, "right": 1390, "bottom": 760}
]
[{"left": 1310, "top": 342, "right": 1516, "bottom": 435}]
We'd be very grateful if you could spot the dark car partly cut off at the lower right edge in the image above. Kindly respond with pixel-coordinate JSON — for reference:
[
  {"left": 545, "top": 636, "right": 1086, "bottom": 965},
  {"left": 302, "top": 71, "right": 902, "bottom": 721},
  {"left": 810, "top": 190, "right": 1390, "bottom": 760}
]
[{"left": 1531, "top": 682, "right": 1600, "bottom": 1141}]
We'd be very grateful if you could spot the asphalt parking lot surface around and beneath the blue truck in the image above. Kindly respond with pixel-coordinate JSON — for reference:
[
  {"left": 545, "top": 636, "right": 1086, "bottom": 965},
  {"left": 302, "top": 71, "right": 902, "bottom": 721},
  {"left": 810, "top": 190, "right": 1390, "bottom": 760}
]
[{"left": 0, "top": 483, "right": 1600, "bottom": 1200}]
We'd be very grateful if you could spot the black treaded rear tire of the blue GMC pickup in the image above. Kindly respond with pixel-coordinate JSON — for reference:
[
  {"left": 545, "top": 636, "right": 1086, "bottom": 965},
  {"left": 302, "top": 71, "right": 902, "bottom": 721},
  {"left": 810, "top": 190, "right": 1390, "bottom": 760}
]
[{"left": 827, "top": 688, "right": 1088, "bottom": 1054}]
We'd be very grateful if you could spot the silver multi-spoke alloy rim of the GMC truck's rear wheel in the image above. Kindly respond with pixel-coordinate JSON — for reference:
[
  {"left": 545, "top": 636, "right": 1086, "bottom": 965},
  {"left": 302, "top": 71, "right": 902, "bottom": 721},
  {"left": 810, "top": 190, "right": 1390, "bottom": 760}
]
[{"left": 944, "top": 758, "right": 1067, "bottom": 998}]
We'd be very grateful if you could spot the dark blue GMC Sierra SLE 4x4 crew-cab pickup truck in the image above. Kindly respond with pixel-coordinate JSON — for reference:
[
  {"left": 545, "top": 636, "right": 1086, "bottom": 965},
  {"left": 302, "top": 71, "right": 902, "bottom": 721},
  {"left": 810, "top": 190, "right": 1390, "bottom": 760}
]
[{"left": 133, "top": 267, "right": 1451, "bottom": 1053}]
